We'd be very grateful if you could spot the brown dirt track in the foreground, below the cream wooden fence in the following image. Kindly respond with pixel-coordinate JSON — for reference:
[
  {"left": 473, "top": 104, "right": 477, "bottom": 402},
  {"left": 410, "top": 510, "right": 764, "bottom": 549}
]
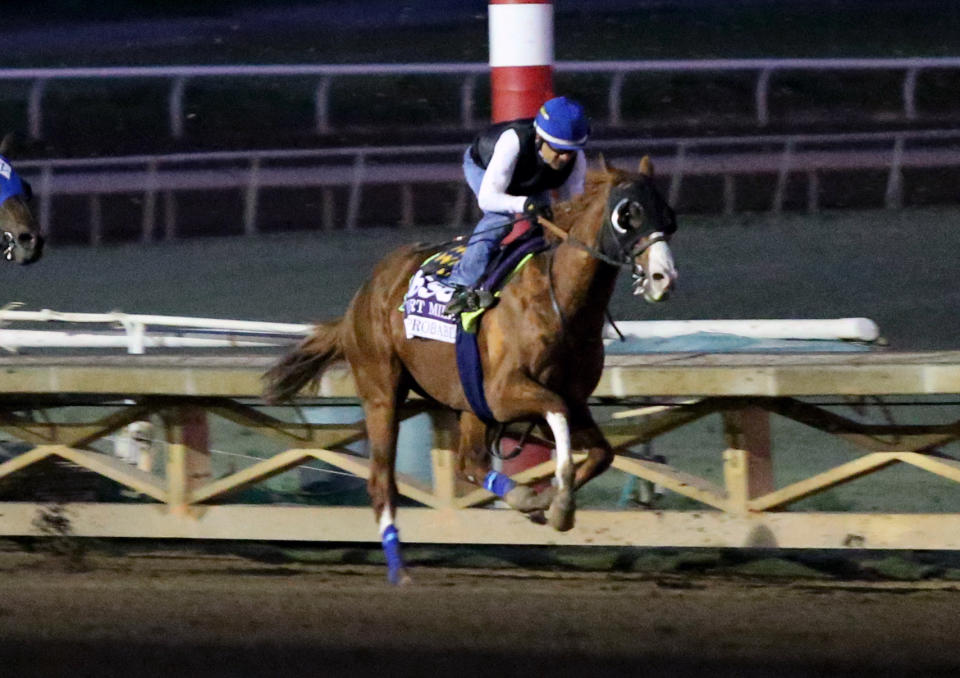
[{"left": 0, "top": 553, "right": 960, "bottom": 678}]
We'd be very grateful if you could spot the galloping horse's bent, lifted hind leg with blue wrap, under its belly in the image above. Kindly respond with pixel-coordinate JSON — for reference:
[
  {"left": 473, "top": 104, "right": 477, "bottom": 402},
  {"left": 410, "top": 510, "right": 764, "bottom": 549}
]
[{"left": 457, "top": 412, "right": 550, "bottom": 513}]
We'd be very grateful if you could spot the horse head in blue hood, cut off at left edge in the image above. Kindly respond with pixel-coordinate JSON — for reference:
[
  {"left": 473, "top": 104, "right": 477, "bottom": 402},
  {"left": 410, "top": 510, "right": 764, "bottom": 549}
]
[{"left": 0, "top": 134, "right": 43, "bottom": 264}]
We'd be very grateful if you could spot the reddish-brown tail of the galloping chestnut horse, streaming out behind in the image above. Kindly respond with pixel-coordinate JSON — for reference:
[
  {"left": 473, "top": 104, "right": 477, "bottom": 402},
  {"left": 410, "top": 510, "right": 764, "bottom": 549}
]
[{"left": 263, "top": 319, "right": 343, "bottom": 403}]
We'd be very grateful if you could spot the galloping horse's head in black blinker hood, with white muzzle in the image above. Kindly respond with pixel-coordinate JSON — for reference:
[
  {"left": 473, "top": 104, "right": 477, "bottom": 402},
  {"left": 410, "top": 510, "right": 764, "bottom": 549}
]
[{"left": 600, "top": 156, "right": 677, "bottom": 302}]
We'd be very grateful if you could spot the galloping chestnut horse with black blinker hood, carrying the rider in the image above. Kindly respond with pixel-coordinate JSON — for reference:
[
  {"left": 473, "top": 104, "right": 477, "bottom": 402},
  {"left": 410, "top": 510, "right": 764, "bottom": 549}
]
[{"left": 264, "top": 158, "right": 676, "bottom": 583}]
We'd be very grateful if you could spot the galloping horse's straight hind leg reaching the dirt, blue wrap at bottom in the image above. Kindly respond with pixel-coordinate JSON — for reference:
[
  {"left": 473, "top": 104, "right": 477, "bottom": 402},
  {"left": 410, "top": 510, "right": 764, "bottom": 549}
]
[{"left": 363, "top": 393, "right": 410, "bottom": 584}]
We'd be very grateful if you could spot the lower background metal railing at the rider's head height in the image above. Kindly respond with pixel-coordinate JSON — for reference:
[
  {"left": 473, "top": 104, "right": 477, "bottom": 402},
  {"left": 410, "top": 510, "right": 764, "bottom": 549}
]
[{"left": 17, "top": 130, "right": 960, "bottom": 244}]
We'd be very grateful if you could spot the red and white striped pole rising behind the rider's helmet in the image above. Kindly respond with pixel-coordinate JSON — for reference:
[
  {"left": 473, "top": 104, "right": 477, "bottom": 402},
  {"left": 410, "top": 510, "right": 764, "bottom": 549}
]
[{"left": 488, "top": 0, "right": 553, "bottom": 122}]
